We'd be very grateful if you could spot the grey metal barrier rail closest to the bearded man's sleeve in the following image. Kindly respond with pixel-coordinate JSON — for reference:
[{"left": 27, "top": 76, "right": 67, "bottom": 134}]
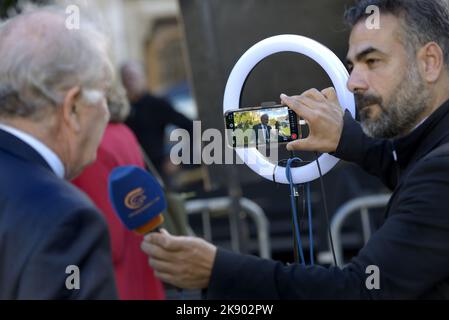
[{"left": 331, "top": 194, "right": 391, "bottom": 267}]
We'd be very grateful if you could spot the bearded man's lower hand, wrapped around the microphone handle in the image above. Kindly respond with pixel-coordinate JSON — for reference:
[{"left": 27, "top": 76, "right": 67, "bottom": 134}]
[{"left": 141, "top": 229, "right": 217, "bottom": 289}]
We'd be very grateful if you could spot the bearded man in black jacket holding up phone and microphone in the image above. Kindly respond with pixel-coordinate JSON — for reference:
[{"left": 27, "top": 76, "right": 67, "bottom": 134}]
[{"left": 142, "top": 0, "right": 449, "bottom": 299}]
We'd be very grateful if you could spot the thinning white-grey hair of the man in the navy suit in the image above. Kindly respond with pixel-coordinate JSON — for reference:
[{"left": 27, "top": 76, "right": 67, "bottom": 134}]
[{"left": 0, "top": 6, "right": 113, "bottom": 120}]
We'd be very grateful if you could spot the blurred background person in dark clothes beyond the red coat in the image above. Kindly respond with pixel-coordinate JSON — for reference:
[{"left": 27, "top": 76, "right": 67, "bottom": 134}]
[{"left": 120, "top": 62, "right": 193, "bottom": 173}]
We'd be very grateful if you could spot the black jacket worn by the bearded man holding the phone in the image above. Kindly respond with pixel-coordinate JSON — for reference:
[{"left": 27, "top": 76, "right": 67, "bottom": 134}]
[{"left": 207, "top": 101, "right": 449, "bottom": 299}]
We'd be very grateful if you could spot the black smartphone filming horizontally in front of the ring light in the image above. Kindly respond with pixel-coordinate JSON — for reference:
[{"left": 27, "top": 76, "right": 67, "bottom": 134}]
[{"left": 224, "top": 105, "right": 302, "bottom": 148}]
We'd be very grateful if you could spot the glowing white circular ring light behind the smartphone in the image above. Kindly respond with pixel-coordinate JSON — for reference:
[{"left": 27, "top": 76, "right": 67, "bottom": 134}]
[{"left": 223, "top": 35, "right": 355, "bottom": 184}]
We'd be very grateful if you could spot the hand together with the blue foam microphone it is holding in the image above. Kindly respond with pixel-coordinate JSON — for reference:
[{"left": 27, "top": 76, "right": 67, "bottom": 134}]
[{"left": 109, "top": 166, "right": 217, "bottom": 289}]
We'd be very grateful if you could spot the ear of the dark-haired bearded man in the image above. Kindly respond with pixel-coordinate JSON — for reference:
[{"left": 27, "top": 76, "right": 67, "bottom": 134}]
[{"left": 417, "top": 42, "right": 444, "bottom": 83}]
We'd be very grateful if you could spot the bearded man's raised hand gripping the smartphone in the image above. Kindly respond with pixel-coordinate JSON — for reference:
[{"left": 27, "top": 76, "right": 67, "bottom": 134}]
[{"left": 281, "top": 88, "right": 344, "bottom": 152}]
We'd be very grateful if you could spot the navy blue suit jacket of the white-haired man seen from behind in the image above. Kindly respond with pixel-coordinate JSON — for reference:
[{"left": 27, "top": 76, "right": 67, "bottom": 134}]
[{"left": 0, "top": 130, "right": 116, "bottom": 299}]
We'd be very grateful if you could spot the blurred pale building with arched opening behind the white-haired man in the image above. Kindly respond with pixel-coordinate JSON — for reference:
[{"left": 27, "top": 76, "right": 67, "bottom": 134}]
[{"left": 53, "top": 0, "right": 197, "bottom": 119}]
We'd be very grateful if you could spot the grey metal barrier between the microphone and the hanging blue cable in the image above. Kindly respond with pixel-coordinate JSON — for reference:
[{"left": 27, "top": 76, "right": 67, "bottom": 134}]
[{"left": 185, "top": 197, "right": 271, "bottom": 259}]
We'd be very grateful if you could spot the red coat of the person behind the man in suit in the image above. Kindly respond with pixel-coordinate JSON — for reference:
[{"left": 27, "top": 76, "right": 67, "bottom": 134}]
[{"left": 72, "top": 124, "right": 165, "bottom": 300}]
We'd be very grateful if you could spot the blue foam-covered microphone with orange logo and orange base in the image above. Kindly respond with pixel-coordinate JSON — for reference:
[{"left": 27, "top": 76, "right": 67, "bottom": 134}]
[{"left": 108, "top": 166, "right": 167, "bottom": 235}]
